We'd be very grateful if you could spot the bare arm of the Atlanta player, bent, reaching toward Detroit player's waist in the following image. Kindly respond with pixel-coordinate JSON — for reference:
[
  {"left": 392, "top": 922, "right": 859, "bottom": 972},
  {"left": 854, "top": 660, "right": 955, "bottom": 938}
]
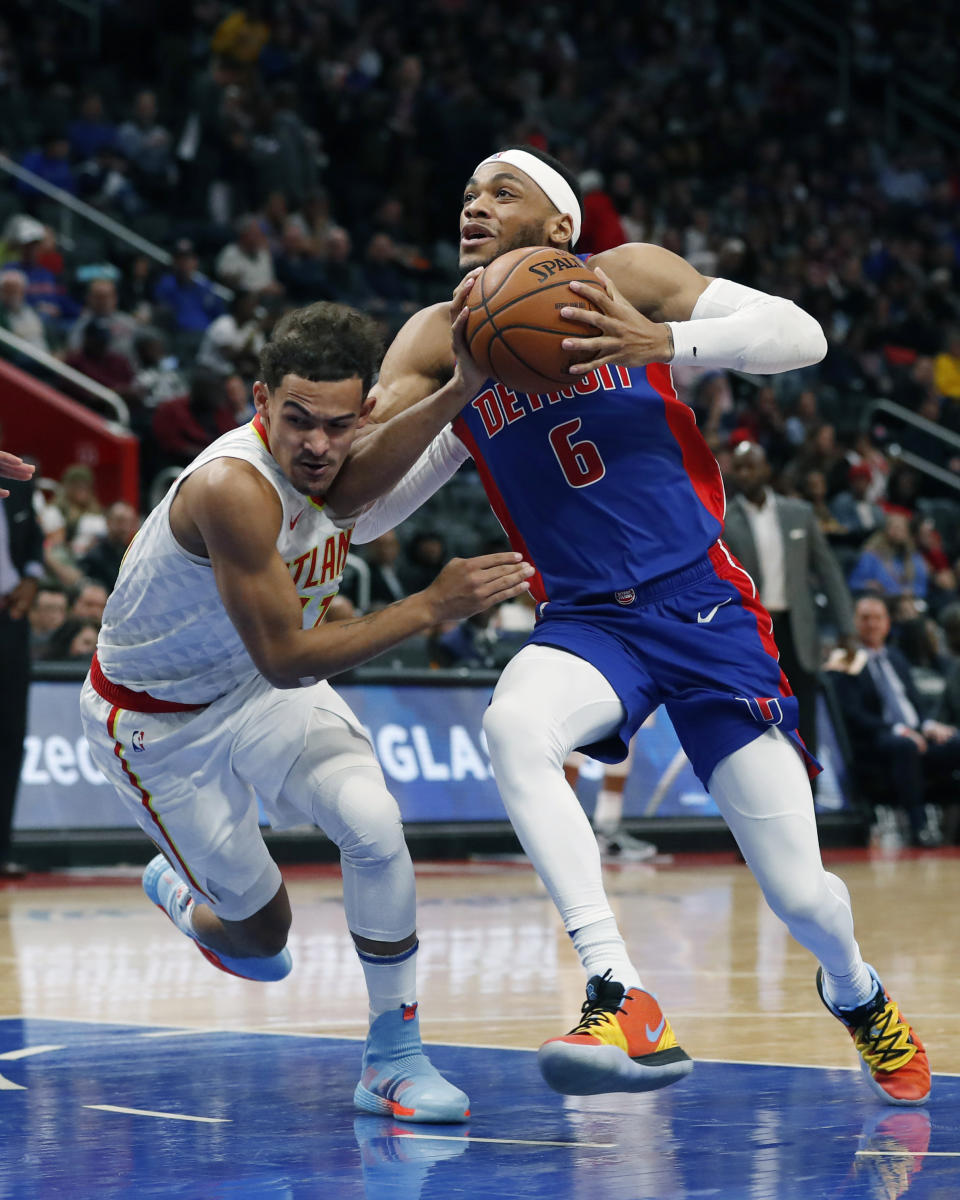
[{"left": 187, "top": 460, "right": 533, "bottom": 688}]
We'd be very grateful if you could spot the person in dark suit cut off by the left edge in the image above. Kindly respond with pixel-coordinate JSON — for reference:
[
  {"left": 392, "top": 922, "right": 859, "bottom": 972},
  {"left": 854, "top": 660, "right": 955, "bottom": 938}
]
[{"left": 0, "top": 453, "right": 43, "bottom": 880}]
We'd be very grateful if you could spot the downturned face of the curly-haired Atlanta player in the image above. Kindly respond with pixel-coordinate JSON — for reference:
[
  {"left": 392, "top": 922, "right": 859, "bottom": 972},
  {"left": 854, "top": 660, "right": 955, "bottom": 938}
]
[{"left": 253, "top": 374, "right": 373, "bottom": 496}]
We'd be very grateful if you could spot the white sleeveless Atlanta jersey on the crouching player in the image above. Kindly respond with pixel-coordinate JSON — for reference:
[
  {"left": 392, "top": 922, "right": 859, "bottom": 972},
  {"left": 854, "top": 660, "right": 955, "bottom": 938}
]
[{"left": 97, "top": 418, "right": 364, "bottom": 704}]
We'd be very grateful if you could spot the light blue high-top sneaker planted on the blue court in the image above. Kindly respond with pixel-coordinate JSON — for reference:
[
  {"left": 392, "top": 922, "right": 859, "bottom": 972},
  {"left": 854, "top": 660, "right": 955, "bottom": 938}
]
[{"left": 353, "top": 1004, "right": 470, "bottom": 1124}]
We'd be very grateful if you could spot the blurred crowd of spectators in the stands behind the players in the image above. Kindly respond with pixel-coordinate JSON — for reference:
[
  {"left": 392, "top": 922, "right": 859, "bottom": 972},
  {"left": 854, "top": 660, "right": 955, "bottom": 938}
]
[{"left": 0, "top": 0, "right": 960, "bottom": 844}]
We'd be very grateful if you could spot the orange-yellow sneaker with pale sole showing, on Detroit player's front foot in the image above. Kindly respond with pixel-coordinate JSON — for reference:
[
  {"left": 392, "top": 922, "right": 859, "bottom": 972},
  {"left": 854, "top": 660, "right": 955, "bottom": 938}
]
[{"left": 536, "top": 971, "right": 694, "bottom": 1096}]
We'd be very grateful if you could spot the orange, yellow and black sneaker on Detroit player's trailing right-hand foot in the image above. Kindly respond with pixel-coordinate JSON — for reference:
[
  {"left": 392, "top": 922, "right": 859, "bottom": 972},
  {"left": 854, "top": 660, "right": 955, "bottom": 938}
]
[{"left": 817, "top": 965, "right": 930, "bottom": 1104}]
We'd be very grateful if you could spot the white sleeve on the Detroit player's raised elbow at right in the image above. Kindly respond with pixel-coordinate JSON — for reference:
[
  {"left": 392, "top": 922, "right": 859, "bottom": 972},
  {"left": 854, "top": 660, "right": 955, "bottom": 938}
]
[{"left": 667, "top": 280, "right": 827, "bottom": 374}]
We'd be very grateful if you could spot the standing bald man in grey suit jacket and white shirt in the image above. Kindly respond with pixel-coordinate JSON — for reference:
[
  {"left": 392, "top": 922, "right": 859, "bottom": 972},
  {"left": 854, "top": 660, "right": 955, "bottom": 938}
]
[{"left": 724, "top": 442, "right": 853, "bottom": 755}]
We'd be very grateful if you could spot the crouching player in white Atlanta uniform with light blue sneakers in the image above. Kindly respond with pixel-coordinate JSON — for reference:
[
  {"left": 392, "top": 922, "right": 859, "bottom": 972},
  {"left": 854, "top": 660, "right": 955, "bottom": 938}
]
[{"left": 80, "top": 304, "right": 533, "bottom": 1121}]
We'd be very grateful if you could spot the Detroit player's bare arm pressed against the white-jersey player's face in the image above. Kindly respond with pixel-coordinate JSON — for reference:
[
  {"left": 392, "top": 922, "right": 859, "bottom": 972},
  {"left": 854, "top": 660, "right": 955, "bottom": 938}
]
[{"left": 326, "top": 269, "right": 484, "bottom": 514}]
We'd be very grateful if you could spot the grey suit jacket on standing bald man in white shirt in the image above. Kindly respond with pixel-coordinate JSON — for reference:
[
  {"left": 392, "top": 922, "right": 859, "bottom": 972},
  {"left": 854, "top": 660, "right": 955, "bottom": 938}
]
[{"left": 724, "top": 493, "right": 853, "bottom": 672}]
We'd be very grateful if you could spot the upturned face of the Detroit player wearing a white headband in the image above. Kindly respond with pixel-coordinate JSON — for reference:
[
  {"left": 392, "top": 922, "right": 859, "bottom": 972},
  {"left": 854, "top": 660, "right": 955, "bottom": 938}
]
[{"left": 460, "top": 162, "right": 566, "bottom": 271}]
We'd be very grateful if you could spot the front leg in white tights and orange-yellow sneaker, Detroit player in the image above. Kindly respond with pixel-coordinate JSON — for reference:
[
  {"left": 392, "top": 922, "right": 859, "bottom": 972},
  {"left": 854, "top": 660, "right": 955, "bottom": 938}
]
[{"left": 484, "top": 646, "right": 692, "bottom": 1094}]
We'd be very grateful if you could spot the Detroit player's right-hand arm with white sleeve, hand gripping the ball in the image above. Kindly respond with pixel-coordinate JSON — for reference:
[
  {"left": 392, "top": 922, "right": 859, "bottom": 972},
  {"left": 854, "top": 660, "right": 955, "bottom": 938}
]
[{"left": 563, "top": 242, "right": 827, "bottom": 374}]
